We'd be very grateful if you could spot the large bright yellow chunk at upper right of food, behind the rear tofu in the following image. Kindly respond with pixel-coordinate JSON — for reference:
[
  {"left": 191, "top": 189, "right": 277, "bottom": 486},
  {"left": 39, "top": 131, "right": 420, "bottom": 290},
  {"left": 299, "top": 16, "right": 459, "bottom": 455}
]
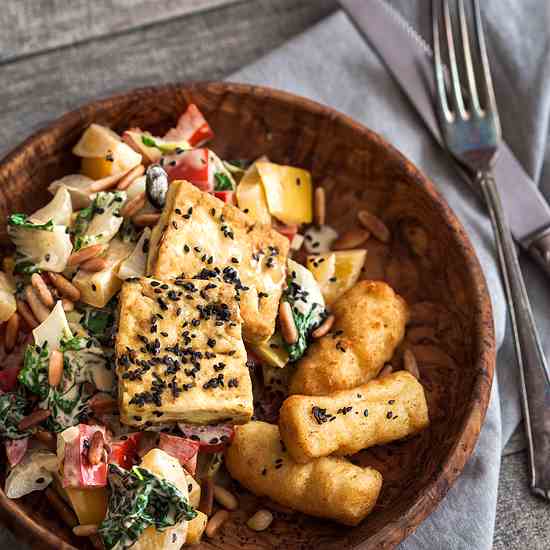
[{"left": 256, "top": 162, "right": 313, "bottom": 225}]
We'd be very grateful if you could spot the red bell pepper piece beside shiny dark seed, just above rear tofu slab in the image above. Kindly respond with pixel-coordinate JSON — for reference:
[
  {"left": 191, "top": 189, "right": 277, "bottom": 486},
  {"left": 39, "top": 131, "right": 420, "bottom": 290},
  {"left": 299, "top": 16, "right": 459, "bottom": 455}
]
[{"left": 163, "top": 148, "right": 214, "bottom": 192}]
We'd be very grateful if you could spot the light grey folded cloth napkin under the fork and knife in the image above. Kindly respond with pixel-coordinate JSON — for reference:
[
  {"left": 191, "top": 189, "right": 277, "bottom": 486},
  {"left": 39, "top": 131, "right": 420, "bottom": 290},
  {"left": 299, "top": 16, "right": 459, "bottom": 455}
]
[{"left": 229, "top": 0, "right": 550, "bottom": 550}]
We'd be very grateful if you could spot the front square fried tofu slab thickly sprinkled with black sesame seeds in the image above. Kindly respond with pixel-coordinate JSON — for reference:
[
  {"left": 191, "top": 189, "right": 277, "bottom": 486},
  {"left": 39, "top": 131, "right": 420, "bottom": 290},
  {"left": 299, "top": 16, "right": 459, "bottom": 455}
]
[{"left": 115, "top": 278, "right": 253, "bottom": 426}]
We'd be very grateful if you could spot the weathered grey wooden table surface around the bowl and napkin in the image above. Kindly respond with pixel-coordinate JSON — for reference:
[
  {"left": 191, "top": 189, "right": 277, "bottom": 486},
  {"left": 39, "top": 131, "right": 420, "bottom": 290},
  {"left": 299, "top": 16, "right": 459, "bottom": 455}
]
[{"left": 0, "top": 0, "right": 550, "bottom": 550}]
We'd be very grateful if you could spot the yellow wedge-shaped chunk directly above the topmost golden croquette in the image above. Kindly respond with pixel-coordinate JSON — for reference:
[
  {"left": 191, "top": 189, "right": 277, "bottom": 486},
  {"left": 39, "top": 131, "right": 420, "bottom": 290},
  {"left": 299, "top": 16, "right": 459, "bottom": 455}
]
[{"left": 307, "top": 249, "right": 367, "bottom": 307}]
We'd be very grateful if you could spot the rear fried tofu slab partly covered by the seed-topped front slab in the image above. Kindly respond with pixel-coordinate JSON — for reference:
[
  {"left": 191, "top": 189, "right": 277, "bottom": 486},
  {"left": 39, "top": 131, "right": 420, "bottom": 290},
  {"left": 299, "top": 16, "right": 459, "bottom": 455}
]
[{"left": 148, "top": 181, "right": 289, "bottom": 342}]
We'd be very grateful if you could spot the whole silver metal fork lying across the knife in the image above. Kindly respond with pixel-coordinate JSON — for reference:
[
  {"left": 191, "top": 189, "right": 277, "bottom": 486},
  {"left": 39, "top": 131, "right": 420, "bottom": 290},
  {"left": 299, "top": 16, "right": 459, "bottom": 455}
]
[{"left": 432, "top": 0, "right": 550, "bottom": 500}]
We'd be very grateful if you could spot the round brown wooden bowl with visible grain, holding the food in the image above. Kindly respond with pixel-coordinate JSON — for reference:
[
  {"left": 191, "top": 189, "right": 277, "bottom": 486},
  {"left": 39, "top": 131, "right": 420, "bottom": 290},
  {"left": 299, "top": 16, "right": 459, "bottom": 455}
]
[{"left": 0, "top": 82, "right": 495, "bottom": 550}]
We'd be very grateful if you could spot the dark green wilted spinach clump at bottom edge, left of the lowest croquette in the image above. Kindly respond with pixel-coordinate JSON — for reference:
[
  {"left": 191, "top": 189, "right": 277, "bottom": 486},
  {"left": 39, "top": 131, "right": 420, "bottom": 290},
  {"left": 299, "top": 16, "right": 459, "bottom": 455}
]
[{"left": 99, "top": 464, "right": 197, "bottom": 550}]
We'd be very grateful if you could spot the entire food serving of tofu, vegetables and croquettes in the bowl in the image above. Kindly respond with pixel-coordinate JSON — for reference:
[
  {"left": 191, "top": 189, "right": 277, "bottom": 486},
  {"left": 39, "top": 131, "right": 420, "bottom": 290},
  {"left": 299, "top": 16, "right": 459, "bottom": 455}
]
[{"left": 0, "top": 105, "right": 429, "bottom": 550}]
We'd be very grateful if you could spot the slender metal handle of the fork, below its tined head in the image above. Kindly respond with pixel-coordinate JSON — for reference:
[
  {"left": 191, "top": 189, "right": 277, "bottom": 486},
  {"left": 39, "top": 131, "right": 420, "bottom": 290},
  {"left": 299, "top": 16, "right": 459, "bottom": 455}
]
[{"left": 477, "top": 172, "right": 550, "bottom": 500}]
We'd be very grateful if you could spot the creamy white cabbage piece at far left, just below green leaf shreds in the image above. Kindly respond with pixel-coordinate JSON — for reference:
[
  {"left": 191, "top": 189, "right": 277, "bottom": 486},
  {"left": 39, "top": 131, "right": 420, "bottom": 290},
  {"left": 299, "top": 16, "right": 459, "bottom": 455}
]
[{"left": 8, "top": 225, "right": 73, "bottom": 273}]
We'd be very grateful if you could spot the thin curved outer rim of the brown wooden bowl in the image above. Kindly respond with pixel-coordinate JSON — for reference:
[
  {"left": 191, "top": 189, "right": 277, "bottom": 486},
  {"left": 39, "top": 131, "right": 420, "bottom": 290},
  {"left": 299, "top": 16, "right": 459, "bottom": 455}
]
[{"left": 0, "top": 80, "right": 496, "bottom": 550}]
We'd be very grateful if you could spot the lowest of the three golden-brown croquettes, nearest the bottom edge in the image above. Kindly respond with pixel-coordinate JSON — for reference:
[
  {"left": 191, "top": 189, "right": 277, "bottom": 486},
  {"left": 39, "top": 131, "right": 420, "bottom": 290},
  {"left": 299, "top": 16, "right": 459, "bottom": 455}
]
[{"left": 225, "top": 422, "right": 382, "bottom": 525}]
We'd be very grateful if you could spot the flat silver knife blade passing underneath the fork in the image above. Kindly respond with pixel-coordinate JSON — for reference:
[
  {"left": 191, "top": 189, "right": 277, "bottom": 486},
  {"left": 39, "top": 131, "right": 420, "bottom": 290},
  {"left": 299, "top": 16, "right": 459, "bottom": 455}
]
[{"left": 339, "top": 0, "right": 550, "bottom": 277}]
